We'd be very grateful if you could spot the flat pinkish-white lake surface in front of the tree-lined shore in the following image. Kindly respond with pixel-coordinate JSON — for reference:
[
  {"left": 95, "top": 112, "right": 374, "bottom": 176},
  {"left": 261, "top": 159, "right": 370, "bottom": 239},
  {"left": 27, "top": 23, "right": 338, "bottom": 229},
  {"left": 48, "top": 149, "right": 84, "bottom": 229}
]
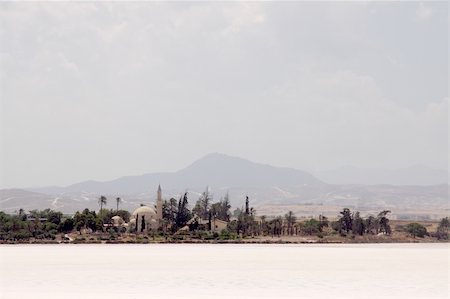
[{"left": 0, "top": 244, "right": 450, "bottom": 299}]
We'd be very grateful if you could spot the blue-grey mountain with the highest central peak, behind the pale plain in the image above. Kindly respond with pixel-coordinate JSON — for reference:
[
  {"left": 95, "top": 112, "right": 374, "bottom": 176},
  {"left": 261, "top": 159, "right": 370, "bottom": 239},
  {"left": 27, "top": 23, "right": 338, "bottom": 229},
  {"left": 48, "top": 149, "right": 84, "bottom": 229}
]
[{"left": 32, "top": 153, "right": 324, "bottom": 194}]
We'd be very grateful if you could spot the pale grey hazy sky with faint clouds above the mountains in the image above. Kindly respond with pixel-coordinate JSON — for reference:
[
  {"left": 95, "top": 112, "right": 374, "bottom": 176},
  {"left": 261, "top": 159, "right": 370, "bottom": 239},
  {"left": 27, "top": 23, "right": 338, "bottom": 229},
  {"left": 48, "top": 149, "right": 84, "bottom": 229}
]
[{"left": 0, "top": 2, "right": 449, "bottom": 188}]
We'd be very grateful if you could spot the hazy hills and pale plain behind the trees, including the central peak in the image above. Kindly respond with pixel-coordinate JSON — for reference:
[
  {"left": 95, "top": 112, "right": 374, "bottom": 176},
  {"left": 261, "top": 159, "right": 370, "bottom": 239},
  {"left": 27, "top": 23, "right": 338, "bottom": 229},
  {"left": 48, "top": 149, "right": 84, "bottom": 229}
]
[{"left": 0, "top": 153, "right": 449, "bottom": 218}]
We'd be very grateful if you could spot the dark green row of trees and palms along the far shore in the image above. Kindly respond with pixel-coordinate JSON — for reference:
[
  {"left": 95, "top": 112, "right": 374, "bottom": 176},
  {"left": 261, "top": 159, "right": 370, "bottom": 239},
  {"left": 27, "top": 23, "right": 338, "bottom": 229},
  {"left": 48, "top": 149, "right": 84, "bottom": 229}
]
[{"left": 0, "top": 188, "right": 450, "bottom": 240}]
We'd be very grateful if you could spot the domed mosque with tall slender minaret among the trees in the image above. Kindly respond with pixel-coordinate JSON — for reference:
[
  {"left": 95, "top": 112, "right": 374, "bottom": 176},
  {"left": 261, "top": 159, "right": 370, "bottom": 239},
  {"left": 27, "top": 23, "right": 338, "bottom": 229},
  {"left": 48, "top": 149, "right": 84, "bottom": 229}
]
[{"left": 129, "top": 185, "right": 163, "bottom": 233}]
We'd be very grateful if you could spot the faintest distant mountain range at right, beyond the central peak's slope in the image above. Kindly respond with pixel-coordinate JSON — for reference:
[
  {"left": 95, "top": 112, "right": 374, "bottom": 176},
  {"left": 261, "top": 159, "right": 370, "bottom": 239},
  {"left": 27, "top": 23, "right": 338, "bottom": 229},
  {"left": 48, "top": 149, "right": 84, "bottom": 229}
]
[{"left": 315, "top": 165, "right": 449, "bottom": 186}]
